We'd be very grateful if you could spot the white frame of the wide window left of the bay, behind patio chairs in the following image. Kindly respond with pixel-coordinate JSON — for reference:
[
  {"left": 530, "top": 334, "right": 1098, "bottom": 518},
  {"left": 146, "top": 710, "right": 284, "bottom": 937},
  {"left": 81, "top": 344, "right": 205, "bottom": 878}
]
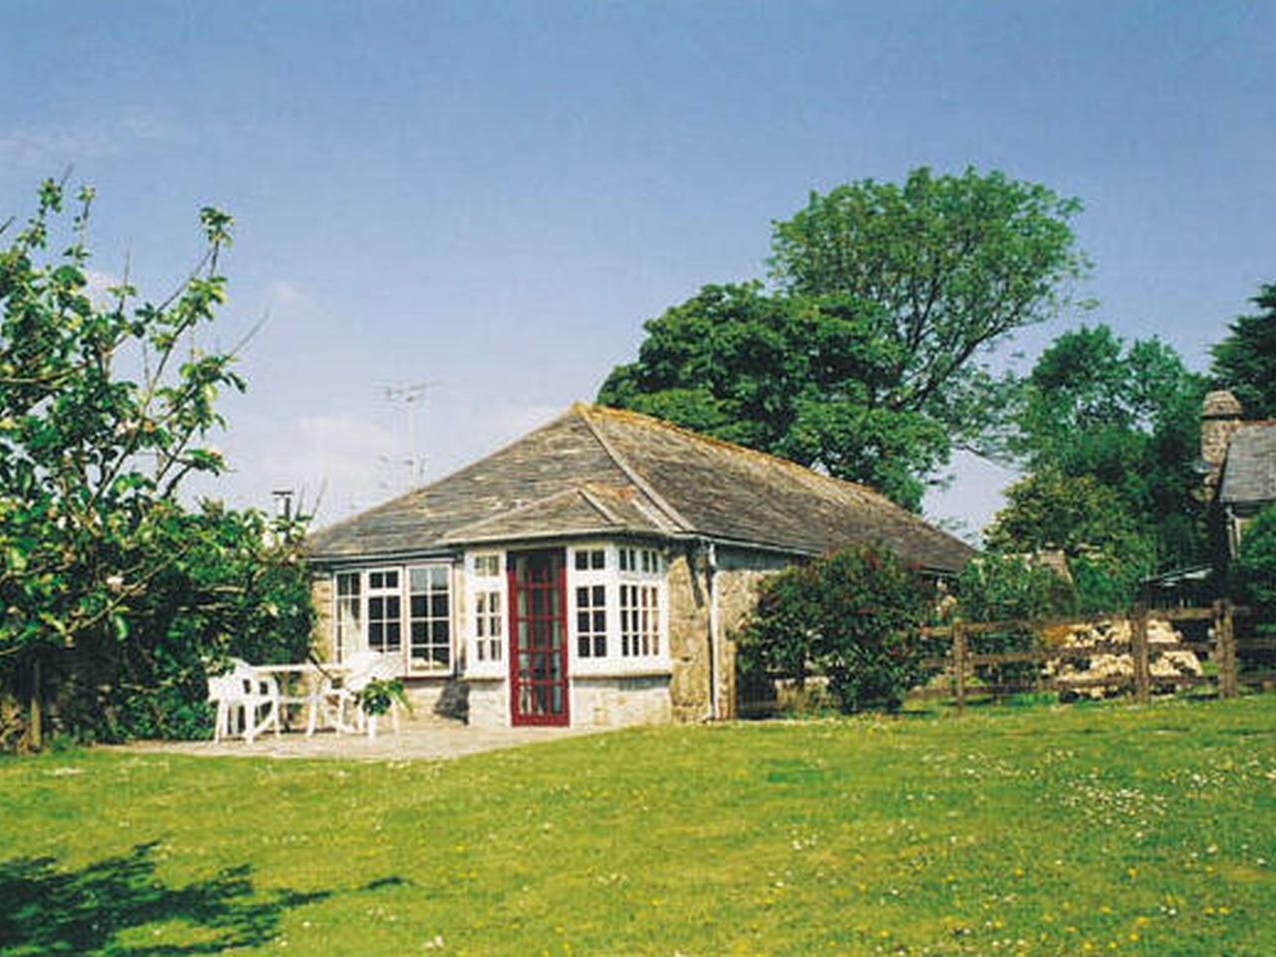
[{"left": 332, "top": 561, "right": 458, "bottom": 678}]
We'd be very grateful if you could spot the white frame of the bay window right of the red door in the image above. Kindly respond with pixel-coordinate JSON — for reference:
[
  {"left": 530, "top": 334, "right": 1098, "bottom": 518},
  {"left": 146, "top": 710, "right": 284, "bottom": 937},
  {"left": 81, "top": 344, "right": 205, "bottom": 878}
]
[{"left": 567, "top": 542, "right": 670, "bottom": 676}]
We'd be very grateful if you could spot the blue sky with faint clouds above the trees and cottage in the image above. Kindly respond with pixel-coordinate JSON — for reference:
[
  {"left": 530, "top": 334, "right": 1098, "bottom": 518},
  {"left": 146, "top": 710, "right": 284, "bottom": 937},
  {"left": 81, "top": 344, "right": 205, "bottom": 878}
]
[{"left": 0, "top": 0, "right": 1276, "bottom": 541}]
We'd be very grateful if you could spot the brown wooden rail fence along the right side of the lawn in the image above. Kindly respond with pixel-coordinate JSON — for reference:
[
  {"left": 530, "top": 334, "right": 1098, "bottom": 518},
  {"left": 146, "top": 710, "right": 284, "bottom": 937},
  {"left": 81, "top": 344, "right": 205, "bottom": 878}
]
[{"left": 738, "top": 601, "right": 1276, "bottom": 717}]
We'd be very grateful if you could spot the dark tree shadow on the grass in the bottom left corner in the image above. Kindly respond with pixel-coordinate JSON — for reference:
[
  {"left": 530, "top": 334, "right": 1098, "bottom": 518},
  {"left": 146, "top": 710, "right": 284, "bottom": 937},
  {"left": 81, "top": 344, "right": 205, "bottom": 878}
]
[{"left": 0, "top": 841, "right": 377, "bottom": 957}]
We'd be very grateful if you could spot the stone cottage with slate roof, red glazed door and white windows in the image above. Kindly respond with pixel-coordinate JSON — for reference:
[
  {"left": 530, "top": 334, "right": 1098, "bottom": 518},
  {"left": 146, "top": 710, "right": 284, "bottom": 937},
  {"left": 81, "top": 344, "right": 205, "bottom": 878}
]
[{"left": 308, "top": 404, "right": 971, "bottom": 726}]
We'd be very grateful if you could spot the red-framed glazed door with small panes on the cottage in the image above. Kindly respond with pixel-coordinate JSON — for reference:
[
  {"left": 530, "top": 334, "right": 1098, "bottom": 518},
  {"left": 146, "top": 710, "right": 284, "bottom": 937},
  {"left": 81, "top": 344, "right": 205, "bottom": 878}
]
[{"left": 509, "top": 549, "right": 570, "bottom": 725}]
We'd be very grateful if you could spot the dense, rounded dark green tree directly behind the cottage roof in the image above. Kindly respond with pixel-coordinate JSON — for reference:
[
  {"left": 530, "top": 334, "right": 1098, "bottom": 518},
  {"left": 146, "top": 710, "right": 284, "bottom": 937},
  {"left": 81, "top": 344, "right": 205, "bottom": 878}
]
[{"left": 598, "top": 283, "right": 948, "bottom": 508}]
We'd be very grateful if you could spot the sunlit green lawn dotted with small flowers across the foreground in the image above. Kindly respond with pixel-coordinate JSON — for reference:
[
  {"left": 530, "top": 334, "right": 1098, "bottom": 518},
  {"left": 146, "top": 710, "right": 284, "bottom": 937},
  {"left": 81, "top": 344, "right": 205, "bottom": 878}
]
[{"left": 0, "top": 695, "right": 1276, "bottom": 957}]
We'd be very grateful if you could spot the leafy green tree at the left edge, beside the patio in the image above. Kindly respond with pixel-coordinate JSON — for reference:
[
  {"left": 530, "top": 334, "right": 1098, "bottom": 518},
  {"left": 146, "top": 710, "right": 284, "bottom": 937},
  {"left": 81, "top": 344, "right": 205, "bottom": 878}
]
[{"left": 0, "top": 181, "right": 305, "bottom": 750}]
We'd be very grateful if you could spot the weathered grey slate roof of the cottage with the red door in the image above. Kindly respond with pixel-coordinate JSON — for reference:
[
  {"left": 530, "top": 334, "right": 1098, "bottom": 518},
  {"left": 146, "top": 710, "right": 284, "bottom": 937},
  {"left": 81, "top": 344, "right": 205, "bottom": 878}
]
[{"left": 308, "top": 403, "right": 974, "bottom": 570}]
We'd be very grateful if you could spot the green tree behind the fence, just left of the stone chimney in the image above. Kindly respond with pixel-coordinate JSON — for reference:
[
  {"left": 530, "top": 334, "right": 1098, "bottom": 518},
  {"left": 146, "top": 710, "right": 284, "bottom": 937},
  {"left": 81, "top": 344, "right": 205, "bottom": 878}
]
[{"left": 985, "top": 325, "right": 1205, "bottom": 591}]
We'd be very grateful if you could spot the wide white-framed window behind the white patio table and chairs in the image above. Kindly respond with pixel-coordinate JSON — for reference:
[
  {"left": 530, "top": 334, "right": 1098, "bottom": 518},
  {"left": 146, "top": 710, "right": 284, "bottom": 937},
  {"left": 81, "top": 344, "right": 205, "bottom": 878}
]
[{"left": 333, "top": 563, "right": 454, "bottom": 674}]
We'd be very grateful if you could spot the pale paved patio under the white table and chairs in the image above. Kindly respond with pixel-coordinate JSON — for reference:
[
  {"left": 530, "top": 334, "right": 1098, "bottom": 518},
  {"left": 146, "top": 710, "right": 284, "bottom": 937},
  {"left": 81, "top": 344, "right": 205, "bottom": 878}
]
[{"left": 120, "top": 720, "right": 612, "bottom": 760}]
